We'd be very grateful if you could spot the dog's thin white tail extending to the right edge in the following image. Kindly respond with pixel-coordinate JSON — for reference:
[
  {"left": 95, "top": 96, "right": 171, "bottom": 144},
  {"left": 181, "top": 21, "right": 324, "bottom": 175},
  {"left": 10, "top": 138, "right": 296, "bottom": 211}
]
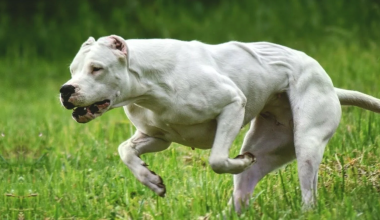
[{"left": 335, "top": 88, "right": 380, "bottom": 113}]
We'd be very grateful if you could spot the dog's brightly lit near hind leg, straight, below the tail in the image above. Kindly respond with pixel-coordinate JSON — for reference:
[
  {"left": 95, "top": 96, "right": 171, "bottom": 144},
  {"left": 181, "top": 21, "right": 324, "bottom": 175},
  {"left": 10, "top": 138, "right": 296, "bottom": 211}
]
[{"left": 289, "top": 67, "right": 341, "bottom": 210}]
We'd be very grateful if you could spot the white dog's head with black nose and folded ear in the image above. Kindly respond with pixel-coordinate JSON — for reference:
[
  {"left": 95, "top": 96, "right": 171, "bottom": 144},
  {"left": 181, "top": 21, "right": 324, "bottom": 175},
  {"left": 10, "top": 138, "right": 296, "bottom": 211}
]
[{"left": 60, "top": 35, "right": 128, "bottom": 123}]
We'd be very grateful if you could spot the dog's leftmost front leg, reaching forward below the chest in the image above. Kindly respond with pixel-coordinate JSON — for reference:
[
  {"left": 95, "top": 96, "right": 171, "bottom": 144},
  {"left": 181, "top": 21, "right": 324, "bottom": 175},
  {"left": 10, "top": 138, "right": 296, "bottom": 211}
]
[{"left": 118, "top": 131, "right": 170, "bottom": 197}]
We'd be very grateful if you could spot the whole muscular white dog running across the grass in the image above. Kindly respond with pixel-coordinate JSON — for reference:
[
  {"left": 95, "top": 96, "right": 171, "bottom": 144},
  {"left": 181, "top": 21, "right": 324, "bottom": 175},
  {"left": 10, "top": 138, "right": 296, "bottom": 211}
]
[{"left": 60, "top": 35, "right": 380, "bottom": 212}]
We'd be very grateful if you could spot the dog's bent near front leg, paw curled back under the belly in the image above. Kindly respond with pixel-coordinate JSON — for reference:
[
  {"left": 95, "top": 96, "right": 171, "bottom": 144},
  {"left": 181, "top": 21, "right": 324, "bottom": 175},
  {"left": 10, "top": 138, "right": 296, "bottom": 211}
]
[{"left": 209, "top": 99, "right": 255, "bottom": 174}]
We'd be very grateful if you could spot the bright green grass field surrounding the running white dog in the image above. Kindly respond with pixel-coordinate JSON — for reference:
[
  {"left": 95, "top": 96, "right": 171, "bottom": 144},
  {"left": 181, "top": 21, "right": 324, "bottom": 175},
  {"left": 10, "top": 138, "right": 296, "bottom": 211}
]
[{"left": 0, "top": 1, "right": 380, "bottom": 220}]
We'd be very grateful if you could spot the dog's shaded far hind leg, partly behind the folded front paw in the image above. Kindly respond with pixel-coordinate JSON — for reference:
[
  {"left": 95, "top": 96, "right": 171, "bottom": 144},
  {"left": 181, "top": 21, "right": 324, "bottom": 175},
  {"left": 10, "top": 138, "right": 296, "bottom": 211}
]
[{"left": 233, "top": 115, "right": 295, "bottom": 213}]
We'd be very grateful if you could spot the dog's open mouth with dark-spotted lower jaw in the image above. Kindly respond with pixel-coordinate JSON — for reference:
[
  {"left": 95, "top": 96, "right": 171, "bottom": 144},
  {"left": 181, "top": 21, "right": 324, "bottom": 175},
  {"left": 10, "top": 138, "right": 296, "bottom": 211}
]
[{"left": 72, "top": 99, "right": 111, "bottom": 123}]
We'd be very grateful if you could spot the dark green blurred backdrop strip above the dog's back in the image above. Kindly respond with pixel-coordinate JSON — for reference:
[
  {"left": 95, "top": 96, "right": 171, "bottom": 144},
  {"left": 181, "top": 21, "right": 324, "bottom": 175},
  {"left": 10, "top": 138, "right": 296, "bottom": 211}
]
[{"left": 0, "top": 0, "right": 380, "bottom": 61}]
